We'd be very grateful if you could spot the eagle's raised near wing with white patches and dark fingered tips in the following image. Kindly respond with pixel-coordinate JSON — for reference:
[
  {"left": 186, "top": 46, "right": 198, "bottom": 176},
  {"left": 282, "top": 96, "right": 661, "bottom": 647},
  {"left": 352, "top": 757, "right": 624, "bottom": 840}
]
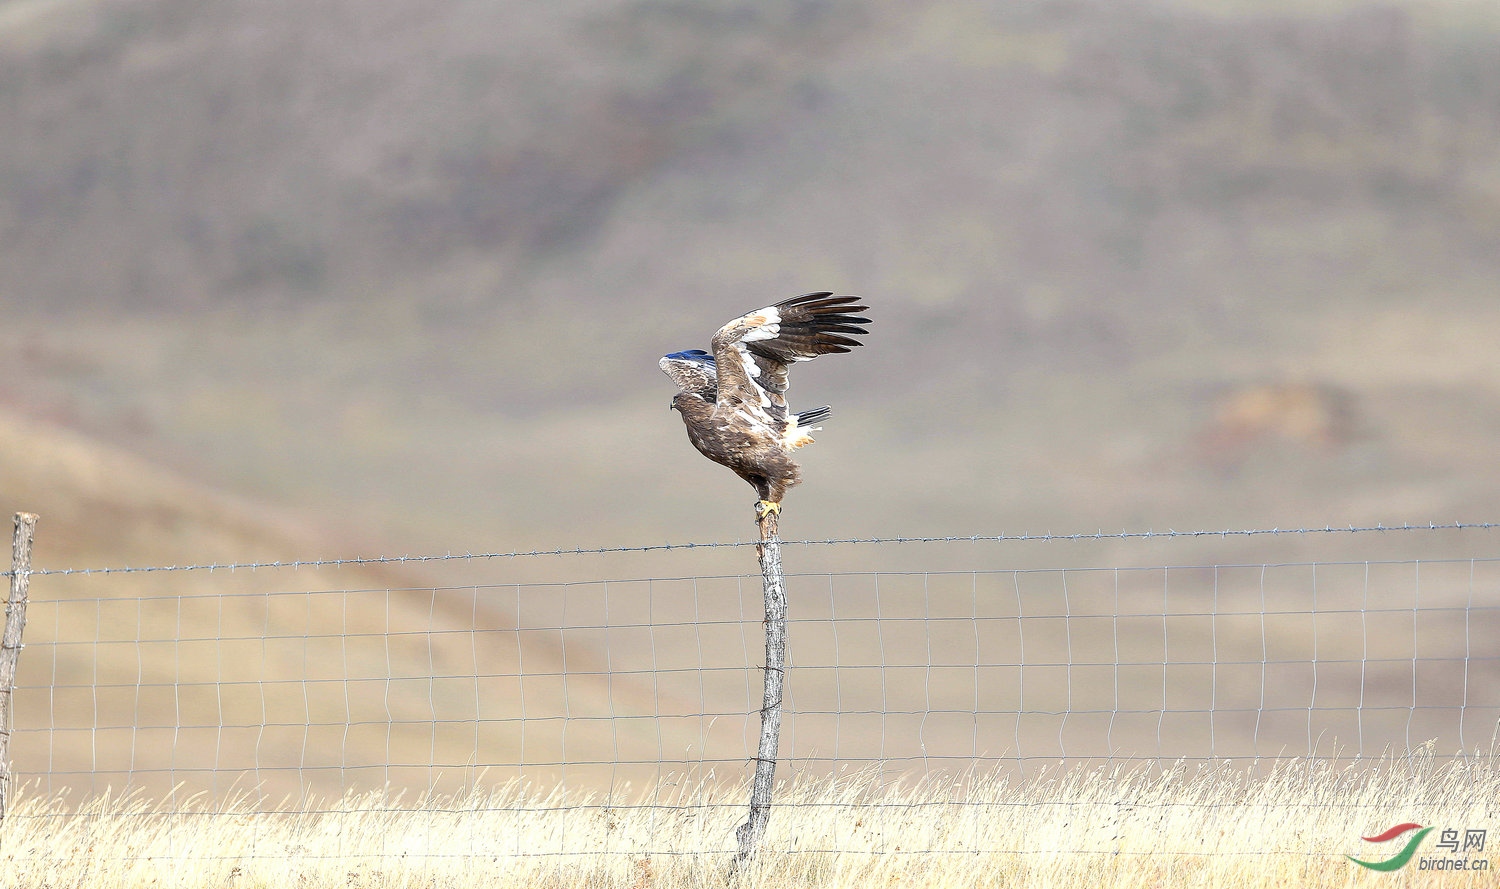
[{"left": 713, "top": 291, "right": 870, "bottom": 433}]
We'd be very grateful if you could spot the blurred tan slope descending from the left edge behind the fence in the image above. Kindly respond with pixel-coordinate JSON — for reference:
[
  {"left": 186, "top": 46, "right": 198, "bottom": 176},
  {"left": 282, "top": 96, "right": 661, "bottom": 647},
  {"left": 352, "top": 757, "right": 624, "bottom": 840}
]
[{"left": 0, "top": 414, "right": 675, "bottom": 801}]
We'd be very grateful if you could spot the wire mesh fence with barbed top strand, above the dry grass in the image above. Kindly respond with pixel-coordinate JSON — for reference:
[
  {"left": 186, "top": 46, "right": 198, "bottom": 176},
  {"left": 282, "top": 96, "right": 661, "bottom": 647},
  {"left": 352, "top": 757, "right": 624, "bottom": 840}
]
[{"left": 9, "top": 523, "right": 1500, "bottom": 861}]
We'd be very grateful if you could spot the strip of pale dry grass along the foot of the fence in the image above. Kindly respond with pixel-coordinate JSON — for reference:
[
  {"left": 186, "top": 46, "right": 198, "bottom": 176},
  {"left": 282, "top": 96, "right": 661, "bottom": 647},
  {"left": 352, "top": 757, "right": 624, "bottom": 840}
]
[{"left": 0, "top": 754, "right": 1500, "bottom": 889}]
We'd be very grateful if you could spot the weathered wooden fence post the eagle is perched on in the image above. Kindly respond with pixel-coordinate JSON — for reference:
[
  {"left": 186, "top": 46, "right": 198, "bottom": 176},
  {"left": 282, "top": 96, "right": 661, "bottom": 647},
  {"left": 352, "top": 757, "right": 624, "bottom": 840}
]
[{"left": 731, "top": 513, "right": 786, "bottom": 873}]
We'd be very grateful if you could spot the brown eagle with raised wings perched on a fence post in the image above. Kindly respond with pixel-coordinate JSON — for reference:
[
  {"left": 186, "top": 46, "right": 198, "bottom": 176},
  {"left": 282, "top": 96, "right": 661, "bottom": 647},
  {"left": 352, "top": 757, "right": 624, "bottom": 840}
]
[{"left": 660, "top": 291, "right": 870, "bottom": 520}]
